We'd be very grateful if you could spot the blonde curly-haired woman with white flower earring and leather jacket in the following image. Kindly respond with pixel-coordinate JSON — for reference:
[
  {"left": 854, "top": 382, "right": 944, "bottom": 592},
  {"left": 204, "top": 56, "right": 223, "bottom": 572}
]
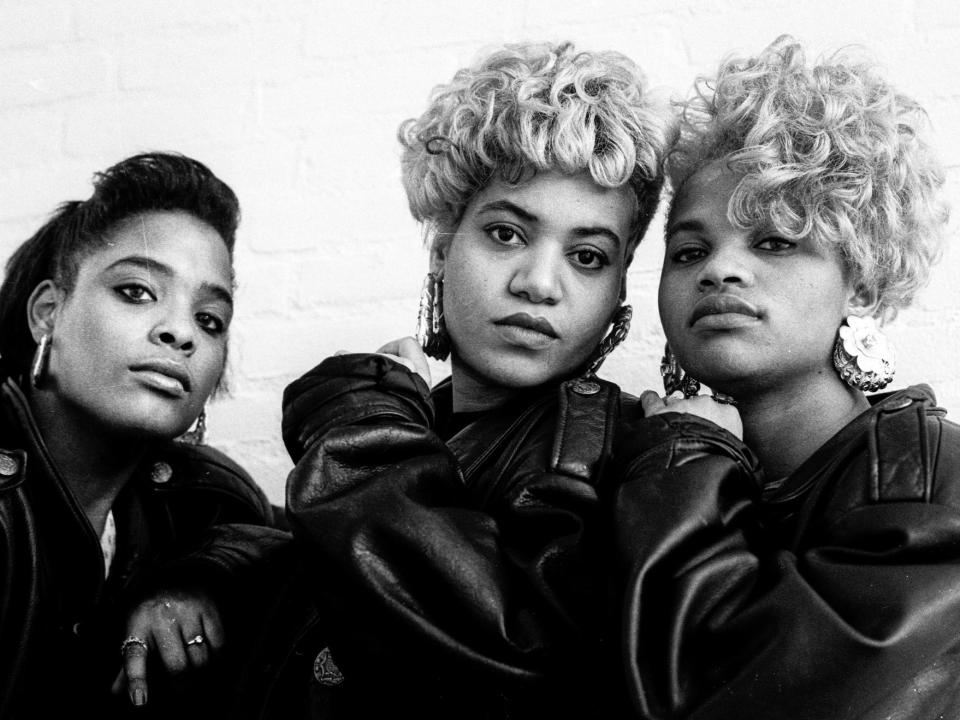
[{"left": 611, "top": 37, "right": 960, "bottom": 720}]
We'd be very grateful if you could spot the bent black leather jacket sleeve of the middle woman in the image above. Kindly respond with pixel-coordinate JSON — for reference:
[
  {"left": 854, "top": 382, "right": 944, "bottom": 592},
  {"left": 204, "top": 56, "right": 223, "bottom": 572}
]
[{"left": 284, "top": 355, "right": 597, "bottom": 678}]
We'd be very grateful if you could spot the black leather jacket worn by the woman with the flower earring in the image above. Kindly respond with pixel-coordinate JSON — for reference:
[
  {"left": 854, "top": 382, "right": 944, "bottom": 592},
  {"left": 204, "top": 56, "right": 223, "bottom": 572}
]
[{"left": 612, "top": 386, "right": 960, "bottom": 720}]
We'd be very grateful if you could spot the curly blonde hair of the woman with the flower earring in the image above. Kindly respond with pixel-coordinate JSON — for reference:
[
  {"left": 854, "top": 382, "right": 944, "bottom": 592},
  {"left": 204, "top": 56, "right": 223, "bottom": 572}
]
[{"left": 667, "top": 35, "right": 948, "bottom": 319}]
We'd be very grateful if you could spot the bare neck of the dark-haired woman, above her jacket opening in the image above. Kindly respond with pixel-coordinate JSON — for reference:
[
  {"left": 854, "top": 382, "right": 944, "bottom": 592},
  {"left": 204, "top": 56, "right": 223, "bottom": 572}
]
[{"left": 28, "top": 391, "right": 146, "bottom": 536}]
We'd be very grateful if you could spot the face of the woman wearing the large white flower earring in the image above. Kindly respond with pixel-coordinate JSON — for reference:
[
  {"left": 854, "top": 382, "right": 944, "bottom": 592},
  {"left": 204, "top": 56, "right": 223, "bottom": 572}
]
[{"left": 660, "top": 163, "right": 862, "bottom": 396}]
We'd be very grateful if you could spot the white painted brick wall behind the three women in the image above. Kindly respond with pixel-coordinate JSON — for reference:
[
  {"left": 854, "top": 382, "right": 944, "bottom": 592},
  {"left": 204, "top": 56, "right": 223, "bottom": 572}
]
[{"left": 0, "top": 0, "right": 960, "bottom": 502}]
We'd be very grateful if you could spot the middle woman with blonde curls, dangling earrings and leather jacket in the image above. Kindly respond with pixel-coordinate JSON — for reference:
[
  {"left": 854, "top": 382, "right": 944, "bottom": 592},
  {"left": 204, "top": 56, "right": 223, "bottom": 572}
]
[{"left": 272, "top": 44, "right": 688, "bottom": 718}]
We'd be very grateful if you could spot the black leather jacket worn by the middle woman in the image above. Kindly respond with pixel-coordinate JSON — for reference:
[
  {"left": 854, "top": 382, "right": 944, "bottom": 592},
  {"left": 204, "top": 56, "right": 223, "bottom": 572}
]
[{"left": 284, "top": 355, "right": 752, "bottom": 718}]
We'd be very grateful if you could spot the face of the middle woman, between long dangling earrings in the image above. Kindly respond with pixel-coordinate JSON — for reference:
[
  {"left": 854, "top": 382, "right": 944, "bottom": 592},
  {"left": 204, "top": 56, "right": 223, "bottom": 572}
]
[{"left": 434, "top": 172, "right": 636, "bottom": 388}]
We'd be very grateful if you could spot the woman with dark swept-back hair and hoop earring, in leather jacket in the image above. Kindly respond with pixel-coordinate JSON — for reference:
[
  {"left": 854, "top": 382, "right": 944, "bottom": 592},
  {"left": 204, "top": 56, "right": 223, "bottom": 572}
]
[{"left": 0, "top": 153, "right": 278, "bottom": 718}]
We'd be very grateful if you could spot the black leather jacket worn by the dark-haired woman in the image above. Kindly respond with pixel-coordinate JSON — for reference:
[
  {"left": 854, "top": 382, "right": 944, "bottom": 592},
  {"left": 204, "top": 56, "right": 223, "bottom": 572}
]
[{"left": 0, "top": 380, "right": 283, "bottom": 720}]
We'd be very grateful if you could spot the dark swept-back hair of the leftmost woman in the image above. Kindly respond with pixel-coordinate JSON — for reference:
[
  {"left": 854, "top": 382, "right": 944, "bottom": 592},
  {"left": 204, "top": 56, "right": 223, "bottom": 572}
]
[{"left": 0, "top": 152, "right": 240, "bottom": 376}]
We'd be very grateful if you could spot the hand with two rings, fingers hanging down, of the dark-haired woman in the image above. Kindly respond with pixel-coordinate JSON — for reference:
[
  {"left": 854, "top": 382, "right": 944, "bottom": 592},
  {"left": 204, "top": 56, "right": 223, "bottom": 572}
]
[{"left": 113, "top": 590, "right": 223, "bottom": 706}]
